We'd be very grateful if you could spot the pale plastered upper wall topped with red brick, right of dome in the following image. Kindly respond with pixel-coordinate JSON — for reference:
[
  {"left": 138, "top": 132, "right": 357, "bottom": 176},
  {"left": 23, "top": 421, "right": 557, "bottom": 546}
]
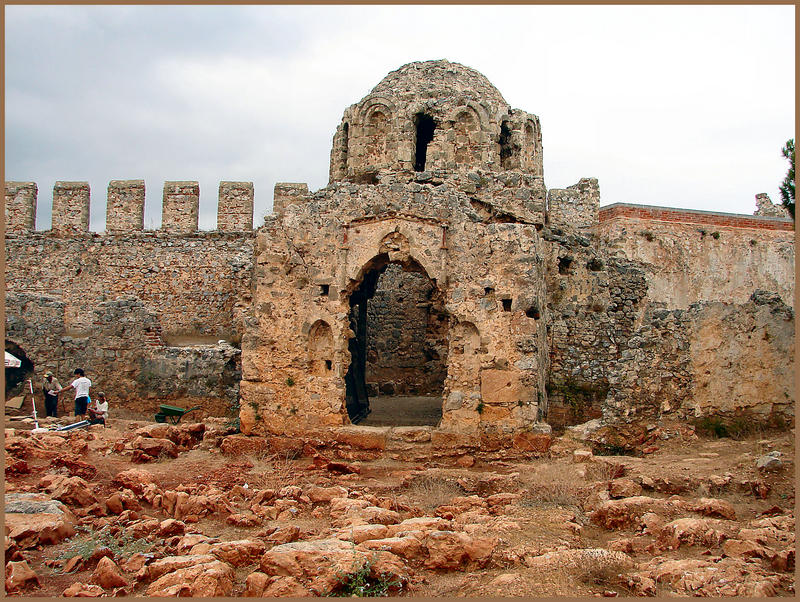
[{"left": 597, "top": 206, "right": 795, "bottom": 309}]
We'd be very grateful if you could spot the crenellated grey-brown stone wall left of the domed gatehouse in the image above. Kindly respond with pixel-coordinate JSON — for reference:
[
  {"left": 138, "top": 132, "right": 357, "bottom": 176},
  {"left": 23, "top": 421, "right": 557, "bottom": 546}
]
[{"left": 5, "top": 180, "right": 254, "bottom": 414}]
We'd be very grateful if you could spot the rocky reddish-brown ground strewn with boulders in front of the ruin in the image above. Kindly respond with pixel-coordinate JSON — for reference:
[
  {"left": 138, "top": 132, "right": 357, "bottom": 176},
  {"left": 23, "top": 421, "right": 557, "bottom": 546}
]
[{"left": 5, "top": 412, "right": 795, "bottom": 597}]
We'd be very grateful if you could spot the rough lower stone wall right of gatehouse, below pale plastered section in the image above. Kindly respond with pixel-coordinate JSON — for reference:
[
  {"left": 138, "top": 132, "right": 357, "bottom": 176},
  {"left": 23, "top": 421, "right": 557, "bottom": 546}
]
[{"left": 543, "top": 219, "right": 794, "bottom": 427}]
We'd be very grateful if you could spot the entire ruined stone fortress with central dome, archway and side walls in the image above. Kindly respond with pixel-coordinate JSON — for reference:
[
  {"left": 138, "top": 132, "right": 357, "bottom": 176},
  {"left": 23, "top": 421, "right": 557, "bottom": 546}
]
[{"left": 5, "top": 61, "right": 795, "bottom": 451}]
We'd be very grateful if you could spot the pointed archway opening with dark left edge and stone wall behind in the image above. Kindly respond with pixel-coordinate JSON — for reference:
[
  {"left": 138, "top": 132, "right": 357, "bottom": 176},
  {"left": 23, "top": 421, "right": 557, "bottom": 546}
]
[{"left": 345, "top": 254, "right": 449, "bottom": 426}]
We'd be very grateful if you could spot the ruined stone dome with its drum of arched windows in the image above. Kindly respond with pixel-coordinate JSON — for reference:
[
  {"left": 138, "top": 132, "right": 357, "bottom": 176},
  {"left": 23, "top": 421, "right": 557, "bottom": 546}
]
[{"left": 330, "top": 60, "right": 542, "bottom": 183}]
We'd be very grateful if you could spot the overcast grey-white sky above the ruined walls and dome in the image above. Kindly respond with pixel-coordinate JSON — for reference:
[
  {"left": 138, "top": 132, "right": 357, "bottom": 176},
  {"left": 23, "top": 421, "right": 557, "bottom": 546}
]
[{"left": 5, "top": 6, "right": 795, "bottom": 231}]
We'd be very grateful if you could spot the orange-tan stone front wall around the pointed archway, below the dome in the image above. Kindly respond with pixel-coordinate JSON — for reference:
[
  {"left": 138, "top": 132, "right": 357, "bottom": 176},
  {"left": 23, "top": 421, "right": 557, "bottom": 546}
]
[{"left": 240, "top": 175, "right": 546, "bottom": 433}]
